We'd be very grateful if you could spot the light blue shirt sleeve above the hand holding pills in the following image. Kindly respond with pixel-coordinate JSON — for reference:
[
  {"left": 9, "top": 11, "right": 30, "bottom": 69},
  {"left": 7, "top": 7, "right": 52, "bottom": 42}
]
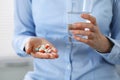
[{"left": 12, "top": 0, "right": 35, "bottom": 56}]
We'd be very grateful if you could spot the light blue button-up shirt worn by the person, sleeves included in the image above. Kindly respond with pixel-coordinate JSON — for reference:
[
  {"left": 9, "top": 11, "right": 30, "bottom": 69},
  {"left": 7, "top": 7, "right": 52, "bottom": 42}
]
[{"left": 13, "top": 0, "right": 120, "bottom": 80}]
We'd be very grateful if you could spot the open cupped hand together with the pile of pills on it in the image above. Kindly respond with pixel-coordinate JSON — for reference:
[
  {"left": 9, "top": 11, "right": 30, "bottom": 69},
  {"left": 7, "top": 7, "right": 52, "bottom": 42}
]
[{"left": 25, "top": 37, "right": 58, "bottom": 59}]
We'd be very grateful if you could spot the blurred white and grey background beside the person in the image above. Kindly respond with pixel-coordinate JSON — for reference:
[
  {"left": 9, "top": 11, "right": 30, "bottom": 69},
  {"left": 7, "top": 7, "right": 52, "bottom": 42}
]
[{"left": 0, "top": 0, "right": 120, "bottom": 80}]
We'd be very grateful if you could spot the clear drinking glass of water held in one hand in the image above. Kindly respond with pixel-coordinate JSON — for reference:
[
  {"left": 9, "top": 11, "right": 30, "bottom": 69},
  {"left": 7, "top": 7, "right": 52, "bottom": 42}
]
[{"left": 67, "top": 0, "right": 94, "bottom": 43}]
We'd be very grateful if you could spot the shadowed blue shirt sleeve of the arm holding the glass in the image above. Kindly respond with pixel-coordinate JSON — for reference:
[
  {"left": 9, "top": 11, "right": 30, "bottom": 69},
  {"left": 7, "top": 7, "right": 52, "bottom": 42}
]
[{"left": 97, "top": 0, "right": 120, "bottom": 64}]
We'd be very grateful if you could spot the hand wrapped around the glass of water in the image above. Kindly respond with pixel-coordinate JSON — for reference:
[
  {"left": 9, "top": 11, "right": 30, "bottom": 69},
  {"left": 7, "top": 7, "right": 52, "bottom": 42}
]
[{"left": 70, "top": 14, "right": 111, "bottom": 52}]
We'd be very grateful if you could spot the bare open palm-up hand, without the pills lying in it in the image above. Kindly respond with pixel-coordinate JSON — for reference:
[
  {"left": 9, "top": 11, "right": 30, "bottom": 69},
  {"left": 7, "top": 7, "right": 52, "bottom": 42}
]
[{"left": 25, "top": 37, "right": 58, "bottom": 59}]
